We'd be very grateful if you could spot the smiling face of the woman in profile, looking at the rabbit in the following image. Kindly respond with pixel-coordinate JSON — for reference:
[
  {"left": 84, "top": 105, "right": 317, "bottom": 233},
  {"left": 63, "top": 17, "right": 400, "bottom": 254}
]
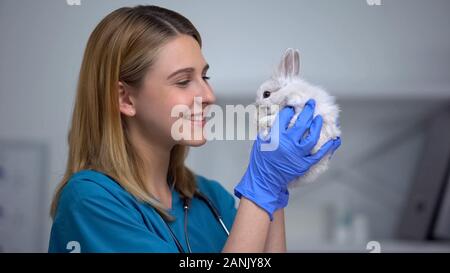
[{"left": 123, "top": 35, "right": 215, "bottom": 149}]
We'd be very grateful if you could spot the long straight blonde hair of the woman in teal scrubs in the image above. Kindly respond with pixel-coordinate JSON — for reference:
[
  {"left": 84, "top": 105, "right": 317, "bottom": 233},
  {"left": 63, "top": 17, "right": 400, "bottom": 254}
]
[{"left": 50, "top": 6, "right": 202, "bottom": 220}]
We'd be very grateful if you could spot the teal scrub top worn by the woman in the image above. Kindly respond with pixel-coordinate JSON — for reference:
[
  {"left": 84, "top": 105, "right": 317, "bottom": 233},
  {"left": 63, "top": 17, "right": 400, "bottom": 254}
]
[{"left": 48, "top": 170, "right": 237, "bottom": 253}]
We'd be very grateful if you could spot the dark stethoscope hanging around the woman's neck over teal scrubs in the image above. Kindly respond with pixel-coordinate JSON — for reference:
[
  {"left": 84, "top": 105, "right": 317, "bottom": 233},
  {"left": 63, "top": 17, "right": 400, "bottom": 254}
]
[{"left": 164, "top": 190, "right": 230, "bottom": 253}]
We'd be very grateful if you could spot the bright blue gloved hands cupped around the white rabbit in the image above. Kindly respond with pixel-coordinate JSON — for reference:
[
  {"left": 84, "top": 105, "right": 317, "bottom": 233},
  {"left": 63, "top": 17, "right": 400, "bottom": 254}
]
[{"left": 234, "top": 100, "right": 341, "bottom": 221}]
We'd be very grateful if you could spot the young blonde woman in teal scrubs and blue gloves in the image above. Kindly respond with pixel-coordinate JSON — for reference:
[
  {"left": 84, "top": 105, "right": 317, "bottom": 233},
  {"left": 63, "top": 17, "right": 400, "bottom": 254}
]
[{"left": 49, "top": 6, "right": 340, "bottom": 252}]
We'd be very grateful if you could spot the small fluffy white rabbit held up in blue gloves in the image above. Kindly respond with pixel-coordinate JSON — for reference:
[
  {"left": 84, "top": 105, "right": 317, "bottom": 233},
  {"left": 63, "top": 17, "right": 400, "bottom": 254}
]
[{"left": 256, "top": 48, "right": 341, "bottom": 188}]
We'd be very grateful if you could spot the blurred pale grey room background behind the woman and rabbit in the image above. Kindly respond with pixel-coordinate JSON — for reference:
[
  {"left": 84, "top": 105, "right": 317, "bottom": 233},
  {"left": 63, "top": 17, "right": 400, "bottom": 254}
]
[{"left": 0, "top": 0, "right": 450, "bottom": 252}]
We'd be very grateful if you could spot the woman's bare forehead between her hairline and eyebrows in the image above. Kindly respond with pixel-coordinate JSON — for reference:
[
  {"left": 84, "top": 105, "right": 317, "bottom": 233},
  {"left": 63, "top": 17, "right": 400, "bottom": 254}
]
[{"left": 154, "top": 34, "right": 206, "bottom": 74}]
